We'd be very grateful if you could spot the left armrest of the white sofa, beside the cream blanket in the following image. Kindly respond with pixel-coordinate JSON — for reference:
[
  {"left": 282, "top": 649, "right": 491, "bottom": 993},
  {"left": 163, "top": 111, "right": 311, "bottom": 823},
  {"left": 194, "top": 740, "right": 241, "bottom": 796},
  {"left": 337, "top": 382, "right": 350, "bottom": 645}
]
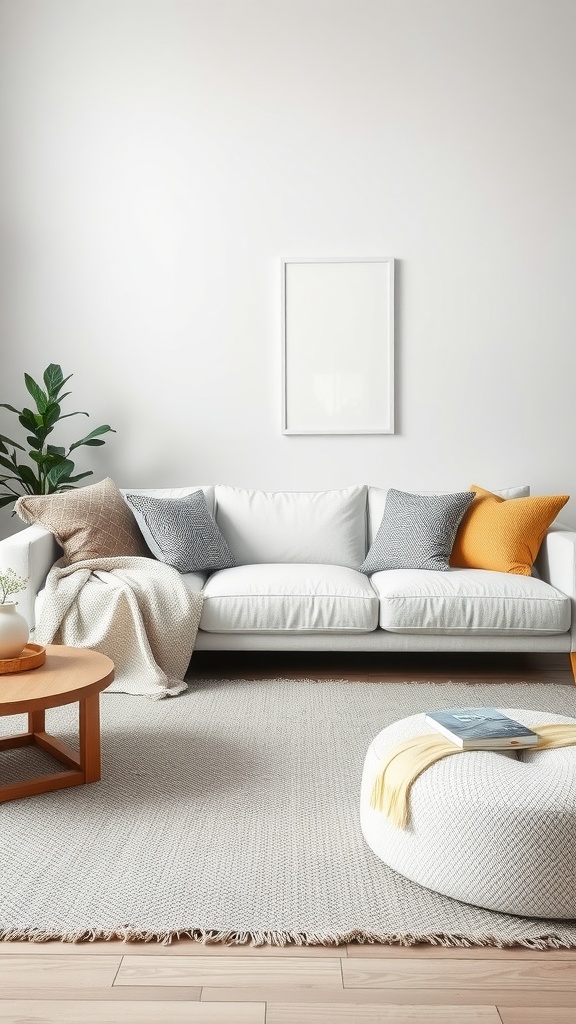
[{"left": 0, "top": 524, "right": 61, "bottom": 631}]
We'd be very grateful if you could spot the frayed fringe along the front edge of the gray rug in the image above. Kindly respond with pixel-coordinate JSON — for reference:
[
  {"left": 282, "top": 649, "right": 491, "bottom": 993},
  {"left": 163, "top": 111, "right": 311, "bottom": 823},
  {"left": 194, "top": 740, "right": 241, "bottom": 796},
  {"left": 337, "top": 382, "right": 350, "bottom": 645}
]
[{"left": 0, "top": 927, "right": 576, "bottom": 950}]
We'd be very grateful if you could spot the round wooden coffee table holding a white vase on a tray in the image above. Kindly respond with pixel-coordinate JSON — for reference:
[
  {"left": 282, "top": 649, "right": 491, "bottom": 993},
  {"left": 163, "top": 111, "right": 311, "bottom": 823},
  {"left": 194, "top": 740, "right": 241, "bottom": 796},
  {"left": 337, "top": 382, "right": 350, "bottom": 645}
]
[{"left": 0, "top": 644, "right": 114, "bottom": 804}]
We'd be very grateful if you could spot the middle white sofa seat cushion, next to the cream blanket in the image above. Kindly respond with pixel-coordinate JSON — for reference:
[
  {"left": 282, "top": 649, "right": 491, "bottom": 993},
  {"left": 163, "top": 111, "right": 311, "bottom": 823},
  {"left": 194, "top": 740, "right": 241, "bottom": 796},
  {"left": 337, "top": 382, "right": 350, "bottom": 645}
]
[{"left": 200, "top": 562, "right": 378, "bottom": 633}]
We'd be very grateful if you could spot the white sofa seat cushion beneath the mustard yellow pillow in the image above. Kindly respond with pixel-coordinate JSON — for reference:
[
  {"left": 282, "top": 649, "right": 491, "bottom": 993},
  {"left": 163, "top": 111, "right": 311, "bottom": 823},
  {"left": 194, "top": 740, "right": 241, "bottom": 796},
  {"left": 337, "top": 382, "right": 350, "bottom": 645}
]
[{"left": 371, "top": 569, "right": 571, "bottom": 636}]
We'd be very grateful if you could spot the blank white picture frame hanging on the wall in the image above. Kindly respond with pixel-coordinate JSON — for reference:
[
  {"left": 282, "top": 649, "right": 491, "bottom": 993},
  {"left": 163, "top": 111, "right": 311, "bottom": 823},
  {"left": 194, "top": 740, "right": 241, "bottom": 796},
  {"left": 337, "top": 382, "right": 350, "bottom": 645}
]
[{"left": 281, "top": 256, "right": 395, "bottom": 434}]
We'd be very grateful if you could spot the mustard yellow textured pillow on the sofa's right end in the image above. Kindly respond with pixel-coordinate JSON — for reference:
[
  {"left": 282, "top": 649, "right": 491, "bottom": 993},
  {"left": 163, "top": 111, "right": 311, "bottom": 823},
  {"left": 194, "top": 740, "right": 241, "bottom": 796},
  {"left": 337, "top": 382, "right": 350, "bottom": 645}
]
[{"left": 450, "top": 483, "right": 570, "bottom": 575}]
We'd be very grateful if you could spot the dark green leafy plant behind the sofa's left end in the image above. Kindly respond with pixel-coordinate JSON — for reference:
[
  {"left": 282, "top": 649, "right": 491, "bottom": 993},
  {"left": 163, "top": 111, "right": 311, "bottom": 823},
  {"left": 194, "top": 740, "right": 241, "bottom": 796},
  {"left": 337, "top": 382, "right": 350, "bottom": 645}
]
[{"left": 0, "top": 362, "right": 116, "bottom": 515}]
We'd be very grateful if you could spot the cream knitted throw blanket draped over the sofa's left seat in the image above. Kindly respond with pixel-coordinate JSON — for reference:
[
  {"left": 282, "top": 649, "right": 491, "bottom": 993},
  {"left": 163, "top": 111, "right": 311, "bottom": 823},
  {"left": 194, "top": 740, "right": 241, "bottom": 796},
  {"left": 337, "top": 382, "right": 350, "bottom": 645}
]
[{"left": 34, "top": 556, "right": 202, "bottom": 699}]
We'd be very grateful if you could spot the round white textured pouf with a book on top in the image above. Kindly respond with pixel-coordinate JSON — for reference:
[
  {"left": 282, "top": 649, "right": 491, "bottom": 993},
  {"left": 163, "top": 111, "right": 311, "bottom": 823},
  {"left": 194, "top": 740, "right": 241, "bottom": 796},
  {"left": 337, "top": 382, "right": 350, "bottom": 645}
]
[{"left": 360, "top": 708, "right": 576, "bottom": 918}]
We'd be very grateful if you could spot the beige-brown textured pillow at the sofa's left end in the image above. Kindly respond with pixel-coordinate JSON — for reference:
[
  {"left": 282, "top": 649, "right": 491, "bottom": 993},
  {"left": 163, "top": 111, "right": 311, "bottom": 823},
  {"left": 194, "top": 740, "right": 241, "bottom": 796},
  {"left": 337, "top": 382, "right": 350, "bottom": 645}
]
[{"left": 14, "top": 476, "right": 150, "bottom": 562}]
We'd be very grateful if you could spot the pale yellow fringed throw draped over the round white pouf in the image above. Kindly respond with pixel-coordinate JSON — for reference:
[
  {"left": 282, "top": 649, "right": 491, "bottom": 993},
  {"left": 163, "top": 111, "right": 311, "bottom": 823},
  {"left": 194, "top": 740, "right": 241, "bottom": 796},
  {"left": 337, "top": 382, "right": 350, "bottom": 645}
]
[{"left": 370, "top": 724, "right": 576, "bottom": 828}]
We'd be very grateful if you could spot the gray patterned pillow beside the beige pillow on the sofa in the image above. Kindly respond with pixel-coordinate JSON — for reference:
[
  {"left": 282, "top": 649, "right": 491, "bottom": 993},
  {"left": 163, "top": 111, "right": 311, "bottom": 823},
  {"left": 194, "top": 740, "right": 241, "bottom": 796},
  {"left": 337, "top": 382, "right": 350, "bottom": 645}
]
[{"left": 125, "top": 490, "right": 236, "bottom": 572}]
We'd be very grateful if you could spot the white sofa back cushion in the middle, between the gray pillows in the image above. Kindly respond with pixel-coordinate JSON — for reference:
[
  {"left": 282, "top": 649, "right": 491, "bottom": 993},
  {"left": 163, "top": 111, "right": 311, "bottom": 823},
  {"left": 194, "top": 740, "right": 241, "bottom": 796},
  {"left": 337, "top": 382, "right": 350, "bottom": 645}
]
[{"left": 215, "top": 484, "right": 367, "bottom": 568}]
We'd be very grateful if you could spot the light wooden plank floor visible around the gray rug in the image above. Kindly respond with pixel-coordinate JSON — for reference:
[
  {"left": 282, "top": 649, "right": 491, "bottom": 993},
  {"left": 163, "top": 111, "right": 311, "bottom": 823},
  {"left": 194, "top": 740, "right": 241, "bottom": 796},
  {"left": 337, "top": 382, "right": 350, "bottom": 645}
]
[{"left": 0, "top": 653, "right": 576, "bottom": 1024}]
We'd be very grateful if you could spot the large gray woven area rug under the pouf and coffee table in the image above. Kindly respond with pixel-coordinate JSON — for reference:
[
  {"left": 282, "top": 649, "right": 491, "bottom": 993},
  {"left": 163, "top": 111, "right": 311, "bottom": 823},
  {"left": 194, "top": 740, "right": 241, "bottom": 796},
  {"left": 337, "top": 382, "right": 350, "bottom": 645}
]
[{"left": 0, "top": 680, "right": 576, "bottom": 948}]
